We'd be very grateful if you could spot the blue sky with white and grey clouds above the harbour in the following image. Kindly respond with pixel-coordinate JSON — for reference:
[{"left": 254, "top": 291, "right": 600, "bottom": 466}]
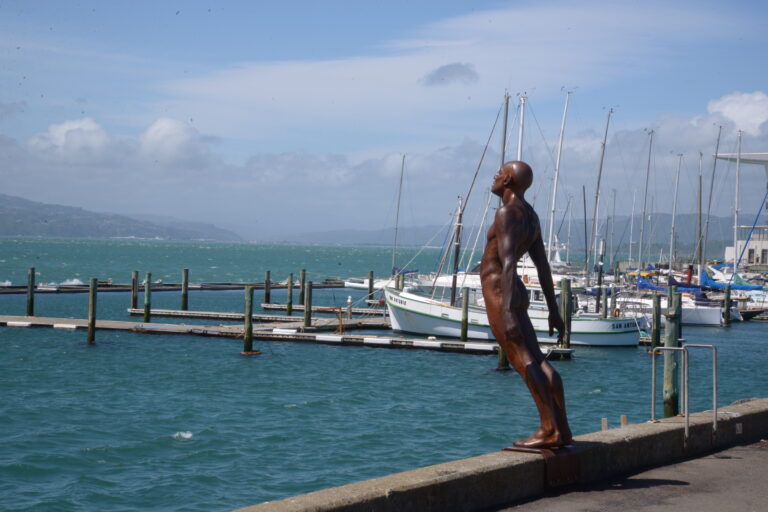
[{"left": 0, "top": 0, "right": 768, "bottom": 240}]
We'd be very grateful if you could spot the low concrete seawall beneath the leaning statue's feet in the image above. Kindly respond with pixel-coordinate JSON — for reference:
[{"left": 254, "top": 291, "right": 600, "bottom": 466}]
[{"left": 232, "top": 398, "right": 768, "bottom": 512}]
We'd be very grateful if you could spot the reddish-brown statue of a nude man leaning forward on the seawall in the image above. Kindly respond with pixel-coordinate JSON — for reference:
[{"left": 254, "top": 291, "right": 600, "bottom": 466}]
[{"left": 480, "top": 162, "right": 573, "bottom": 448}]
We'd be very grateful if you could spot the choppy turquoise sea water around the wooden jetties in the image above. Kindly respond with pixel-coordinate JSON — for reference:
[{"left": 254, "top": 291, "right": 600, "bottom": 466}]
[{"left": 0, "top": 240, "right": 768, "bottom": 511}]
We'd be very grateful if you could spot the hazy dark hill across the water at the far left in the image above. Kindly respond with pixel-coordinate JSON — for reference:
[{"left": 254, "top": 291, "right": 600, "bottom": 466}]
[{"left": 0, "top": 194, "right": 242, "bottom": 242}]
